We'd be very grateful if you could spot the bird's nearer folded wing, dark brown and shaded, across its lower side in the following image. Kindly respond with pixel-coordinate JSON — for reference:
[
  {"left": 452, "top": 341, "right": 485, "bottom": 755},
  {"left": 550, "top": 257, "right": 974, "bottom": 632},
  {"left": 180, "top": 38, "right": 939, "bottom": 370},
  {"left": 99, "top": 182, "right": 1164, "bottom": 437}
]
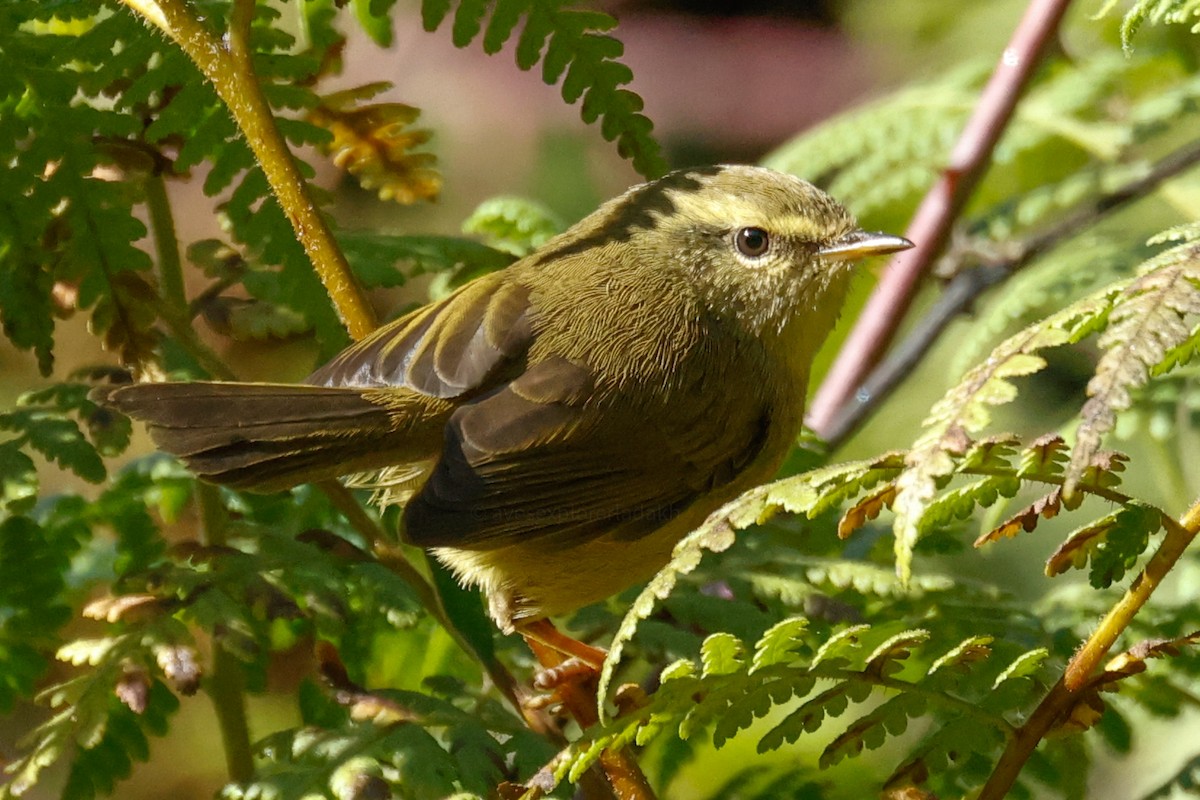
[{"left": 404, "top": 357, "right": 769, "bottom": 549}]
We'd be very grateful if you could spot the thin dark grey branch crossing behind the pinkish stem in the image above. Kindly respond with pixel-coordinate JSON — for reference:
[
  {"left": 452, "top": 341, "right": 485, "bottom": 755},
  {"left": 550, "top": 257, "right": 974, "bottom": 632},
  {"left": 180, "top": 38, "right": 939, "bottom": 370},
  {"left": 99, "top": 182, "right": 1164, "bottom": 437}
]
[{"left": 824, "top": 143, "right": 1200, "bottom": 450}]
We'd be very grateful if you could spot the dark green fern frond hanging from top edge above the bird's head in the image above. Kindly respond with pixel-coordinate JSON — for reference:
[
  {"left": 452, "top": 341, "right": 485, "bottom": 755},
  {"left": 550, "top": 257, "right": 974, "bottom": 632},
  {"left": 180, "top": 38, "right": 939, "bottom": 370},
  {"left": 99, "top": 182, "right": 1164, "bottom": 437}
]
[{"left": 421, "top": 0, "right": 666, "bottom": 178}]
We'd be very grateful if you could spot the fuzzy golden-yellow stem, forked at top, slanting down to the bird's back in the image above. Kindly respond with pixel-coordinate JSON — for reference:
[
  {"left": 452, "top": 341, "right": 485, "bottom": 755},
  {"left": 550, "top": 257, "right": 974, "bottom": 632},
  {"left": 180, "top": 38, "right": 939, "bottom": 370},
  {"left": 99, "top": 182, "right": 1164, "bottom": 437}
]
[{"left": 124, "top": 0, "right": 376, "bottom": 339}]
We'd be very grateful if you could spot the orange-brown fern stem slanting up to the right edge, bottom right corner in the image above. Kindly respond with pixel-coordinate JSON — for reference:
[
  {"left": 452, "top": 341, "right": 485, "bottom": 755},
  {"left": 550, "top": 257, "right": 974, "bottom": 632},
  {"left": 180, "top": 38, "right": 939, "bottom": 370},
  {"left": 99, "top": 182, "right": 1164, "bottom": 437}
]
[{"left": 979, "top": 503, "right": 1200, "bottom": 800}]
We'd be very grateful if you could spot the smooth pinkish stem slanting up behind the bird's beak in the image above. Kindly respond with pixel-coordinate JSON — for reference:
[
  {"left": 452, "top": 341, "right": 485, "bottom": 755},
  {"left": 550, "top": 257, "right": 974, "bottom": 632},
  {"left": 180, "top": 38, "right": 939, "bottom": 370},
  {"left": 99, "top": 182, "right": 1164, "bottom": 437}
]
[{"left": 808, "top": 0, "right": 1070, "bottom": 440}]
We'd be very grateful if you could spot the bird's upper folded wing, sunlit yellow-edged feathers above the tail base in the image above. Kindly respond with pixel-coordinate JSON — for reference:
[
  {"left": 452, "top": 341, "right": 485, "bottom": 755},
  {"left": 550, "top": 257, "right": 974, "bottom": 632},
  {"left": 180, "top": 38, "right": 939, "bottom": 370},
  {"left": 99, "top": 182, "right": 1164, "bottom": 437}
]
[{"left": 306, "top": 272, "right": 533, "bottom": 399}]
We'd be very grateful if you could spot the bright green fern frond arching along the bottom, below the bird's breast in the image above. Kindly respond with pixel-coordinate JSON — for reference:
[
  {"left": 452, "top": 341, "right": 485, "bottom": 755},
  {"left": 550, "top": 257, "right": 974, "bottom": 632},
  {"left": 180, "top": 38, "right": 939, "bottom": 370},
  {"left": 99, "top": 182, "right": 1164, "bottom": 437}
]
[{"left": 566, "top": 618, "right": 1045, "bottom": 796}]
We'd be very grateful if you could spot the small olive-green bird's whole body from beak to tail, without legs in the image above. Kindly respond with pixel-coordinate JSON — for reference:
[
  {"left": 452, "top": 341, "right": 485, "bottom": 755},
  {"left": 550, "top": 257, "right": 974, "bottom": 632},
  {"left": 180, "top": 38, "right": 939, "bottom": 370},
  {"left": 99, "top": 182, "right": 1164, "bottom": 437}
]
[{"left": 107, "top": 167, "right": 908, "bottom": 630}]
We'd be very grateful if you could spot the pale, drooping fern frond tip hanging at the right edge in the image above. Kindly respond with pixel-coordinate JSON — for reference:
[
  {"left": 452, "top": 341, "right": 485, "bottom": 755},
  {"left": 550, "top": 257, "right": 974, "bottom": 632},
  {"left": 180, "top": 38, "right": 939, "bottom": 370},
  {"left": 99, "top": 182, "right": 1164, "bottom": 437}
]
[{"left": 1067, "top": 224, "right": 1200, "bottom": 494}]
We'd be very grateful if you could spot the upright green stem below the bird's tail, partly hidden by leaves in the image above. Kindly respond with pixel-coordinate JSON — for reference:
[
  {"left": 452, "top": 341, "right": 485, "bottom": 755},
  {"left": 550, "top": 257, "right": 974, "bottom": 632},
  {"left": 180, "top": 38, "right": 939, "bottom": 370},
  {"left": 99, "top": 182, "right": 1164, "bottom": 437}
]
[{"left": 196, "top": 483, "right": 254, "bottom": 783}]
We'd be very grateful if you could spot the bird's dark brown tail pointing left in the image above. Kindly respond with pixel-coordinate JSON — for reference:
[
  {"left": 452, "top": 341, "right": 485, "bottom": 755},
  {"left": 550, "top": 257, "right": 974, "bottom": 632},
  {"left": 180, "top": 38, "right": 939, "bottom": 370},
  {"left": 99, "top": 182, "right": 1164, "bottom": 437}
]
[{"left": 92, "top": 381, "right": 427, "bottom": 492}]
